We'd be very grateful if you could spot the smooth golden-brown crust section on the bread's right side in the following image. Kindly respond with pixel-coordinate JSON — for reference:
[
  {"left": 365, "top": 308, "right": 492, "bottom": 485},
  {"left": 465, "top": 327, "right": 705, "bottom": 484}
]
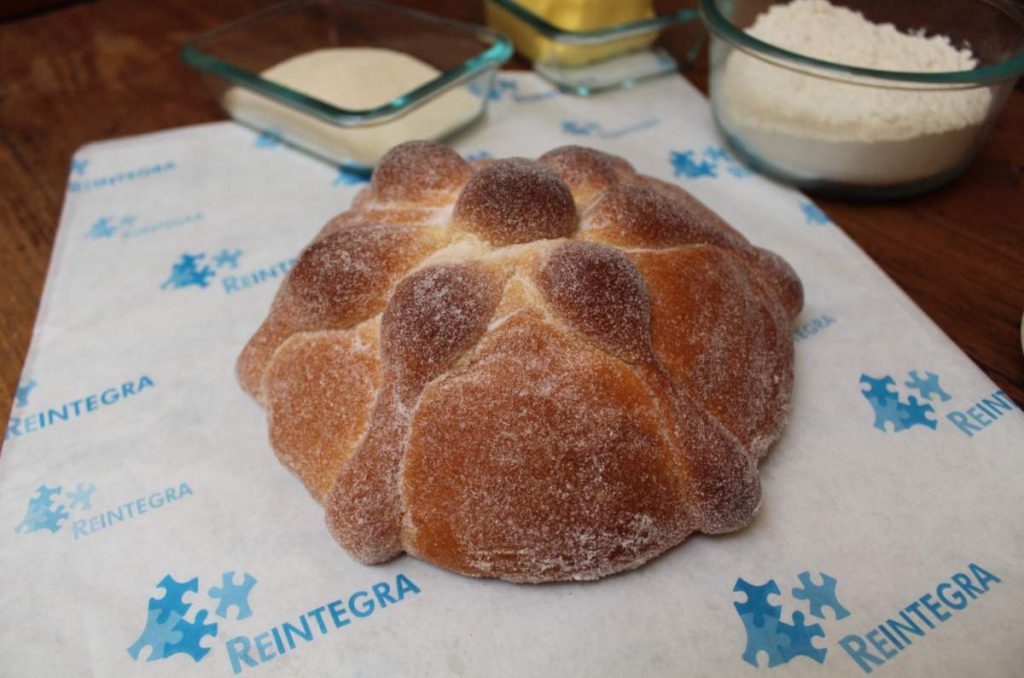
[{"left": 630, "top": 246, "right": 793, "bottom": 455}]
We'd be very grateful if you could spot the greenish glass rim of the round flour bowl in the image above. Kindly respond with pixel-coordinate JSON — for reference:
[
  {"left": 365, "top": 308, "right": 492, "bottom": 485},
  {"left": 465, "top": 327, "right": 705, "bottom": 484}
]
[{"left": 700, "top": 0, "right": 1024, "bottom": 88}]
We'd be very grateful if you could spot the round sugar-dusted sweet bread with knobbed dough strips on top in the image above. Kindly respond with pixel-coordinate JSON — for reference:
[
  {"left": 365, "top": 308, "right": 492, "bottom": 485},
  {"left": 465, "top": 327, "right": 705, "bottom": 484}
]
[{"left": 238, "top": 141, "right": 803, "bottom": 582}]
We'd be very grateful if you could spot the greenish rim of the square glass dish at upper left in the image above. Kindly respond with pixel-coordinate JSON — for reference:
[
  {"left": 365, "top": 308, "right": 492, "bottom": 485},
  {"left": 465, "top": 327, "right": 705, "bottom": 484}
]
[{"left": 180, "top": 0, "right": 513, "bottom": 127}]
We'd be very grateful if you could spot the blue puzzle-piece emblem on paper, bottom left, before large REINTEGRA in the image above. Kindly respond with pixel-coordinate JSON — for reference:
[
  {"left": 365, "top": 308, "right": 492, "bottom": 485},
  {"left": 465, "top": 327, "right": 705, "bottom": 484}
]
[{"left": 128, "top": 570, "right": 256, "bottom": 662}]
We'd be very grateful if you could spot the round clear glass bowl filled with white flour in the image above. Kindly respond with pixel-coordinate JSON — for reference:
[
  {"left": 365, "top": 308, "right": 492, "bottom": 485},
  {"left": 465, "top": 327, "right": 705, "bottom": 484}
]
[{"left": 701, "top": 0, "right": 1024, "bottom": 198}]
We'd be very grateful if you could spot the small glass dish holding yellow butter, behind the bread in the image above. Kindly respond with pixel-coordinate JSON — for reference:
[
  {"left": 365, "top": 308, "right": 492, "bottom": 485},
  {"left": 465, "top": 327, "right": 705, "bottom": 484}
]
[{"left": 484, "top": 0, "right": 705, "bottom": 96}]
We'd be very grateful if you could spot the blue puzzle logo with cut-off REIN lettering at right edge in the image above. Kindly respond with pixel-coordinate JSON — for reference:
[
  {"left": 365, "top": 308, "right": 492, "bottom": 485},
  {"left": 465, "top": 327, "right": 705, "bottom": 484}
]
[{"left": 860, "top": 370, "right": 1016, "bottom": 437}]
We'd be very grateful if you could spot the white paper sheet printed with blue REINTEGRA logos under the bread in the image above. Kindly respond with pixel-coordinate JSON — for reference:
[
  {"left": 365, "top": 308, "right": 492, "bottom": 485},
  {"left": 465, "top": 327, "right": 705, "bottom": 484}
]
[{"left": 0, "top": 74, "right": 1024, "bottom": 678}]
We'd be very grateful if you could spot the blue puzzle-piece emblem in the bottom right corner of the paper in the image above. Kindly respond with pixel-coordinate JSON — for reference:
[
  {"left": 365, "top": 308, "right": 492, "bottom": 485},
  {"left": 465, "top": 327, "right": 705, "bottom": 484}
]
[{"left": 732, "top": 571, "right": 850, "bottom": 668}]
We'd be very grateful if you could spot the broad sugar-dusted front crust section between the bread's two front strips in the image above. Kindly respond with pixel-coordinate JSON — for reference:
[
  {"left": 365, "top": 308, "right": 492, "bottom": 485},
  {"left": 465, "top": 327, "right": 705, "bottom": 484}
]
[{"left": 402, "top": 314, "right": 692, "bottom": 582}]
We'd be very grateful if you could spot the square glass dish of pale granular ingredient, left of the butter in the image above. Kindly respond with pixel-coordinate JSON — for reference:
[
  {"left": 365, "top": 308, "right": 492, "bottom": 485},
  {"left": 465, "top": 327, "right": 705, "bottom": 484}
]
[{"left": 181, "top": 0, "right": 512, "bottom": 172}]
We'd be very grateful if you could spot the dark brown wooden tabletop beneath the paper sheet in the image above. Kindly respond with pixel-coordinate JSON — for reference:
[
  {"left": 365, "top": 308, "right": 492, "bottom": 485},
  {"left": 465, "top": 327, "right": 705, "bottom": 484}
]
[{"left": 0, "top": 0, "right": 1024, "bottom": 426}]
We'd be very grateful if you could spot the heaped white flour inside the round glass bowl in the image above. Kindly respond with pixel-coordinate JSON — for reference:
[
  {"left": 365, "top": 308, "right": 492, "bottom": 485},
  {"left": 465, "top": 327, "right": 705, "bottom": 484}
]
[{"left": 713, "top": 0, "right": 992, "bottom": 185}]
